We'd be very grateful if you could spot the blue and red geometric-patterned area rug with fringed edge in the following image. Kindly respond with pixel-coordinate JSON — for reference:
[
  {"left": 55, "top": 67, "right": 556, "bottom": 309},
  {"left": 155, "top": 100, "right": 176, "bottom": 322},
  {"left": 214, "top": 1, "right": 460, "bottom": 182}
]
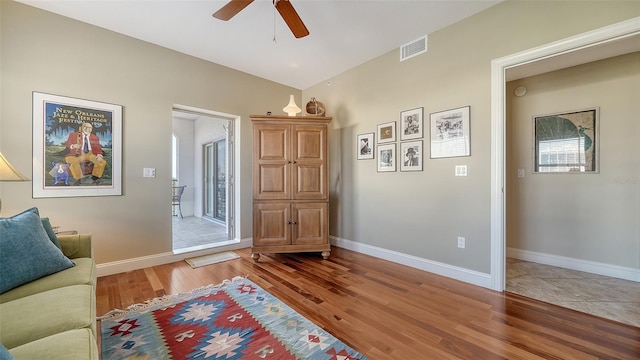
[{"left": 99, "top": 277, "right": 366, "bottom": 360}]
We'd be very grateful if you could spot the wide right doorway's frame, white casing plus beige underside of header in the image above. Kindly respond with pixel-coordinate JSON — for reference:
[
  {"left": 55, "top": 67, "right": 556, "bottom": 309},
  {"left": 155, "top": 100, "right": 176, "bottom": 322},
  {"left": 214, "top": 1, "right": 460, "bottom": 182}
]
[{"left": 491, "top": 18, "right": 640, "bottom": 291}]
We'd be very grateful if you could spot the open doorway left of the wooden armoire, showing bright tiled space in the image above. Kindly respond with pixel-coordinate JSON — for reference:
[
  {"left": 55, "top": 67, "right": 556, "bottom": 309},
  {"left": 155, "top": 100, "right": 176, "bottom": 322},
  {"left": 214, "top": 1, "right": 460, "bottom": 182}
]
[{"left": 171, "top": 106, "right": 239, "bottom": 253}]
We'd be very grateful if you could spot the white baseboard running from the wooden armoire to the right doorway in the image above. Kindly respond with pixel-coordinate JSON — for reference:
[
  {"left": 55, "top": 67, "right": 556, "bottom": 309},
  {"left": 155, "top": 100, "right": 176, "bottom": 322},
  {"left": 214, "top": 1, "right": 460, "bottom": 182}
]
[{"left": 330, "top": 236, "right": 491, "bottom": 289}]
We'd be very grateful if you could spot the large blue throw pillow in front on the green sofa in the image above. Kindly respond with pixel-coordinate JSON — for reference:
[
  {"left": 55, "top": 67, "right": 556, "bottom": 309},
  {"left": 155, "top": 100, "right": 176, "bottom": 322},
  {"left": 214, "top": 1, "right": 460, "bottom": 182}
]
[{"left": 0, "top": 208, "right": 74, "bottom": 294}]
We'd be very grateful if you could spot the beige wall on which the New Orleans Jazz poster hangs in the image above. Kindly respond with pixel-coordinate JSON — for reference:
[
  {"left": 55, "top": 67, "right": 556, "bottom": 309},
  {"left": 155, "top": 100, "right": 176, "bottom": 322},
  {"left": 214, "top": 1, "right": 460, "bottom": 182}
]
[{"left": 0, "top": 1, "right": 301, "bottom": 264}]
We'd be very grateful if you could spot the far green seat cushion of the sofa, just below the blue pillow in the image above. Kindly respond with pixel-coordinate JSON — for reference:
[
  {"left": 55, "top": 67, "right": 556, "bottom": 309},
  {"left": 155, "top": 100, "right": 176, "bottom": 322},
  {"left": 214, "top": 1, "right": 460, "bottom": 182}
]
[{"left": 0, "top": 258, "right": 96, "bottom": 304}]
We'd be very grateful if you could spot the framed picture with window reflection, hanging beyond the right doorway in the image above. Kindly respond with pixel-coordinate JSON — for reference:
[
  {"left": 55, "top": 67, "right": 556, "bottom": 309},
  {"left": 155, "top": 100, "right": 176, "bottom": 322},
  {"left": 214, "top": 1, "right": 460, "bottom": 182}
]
[{"left": 533, "top": 108, "right": 600, "bottom": 174}]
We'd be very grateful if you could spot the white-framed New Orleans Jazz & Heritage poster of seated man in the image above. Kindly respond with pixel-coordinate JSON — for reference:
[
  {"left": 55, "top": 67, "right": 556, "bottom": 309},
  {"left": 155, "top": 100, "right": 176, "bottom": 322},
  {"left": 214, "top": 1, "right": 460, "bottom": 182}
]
[{"left": 33, "top": 92, "right": 122, "bottom": 198}]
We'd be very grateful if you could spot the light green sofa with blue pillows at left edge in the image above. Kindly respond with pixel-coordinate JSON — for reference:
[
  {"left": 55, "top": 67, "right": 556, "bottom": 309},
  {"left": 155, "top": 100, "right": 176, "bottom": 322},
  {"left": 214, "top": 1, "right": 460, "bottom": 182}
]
[{"left": 0, "top": 234, "right": 99, "bottom": 360}]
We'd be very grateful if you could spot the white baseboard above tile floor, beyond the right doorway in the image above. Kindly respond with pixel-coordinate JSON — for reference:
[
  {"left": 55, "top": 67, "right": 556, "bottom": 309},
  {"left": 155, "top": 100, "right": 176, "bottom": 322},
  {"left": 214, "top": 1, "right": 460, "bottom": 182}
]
[{"left": 507, "top": 248, "right": 640, "bottom": 282}]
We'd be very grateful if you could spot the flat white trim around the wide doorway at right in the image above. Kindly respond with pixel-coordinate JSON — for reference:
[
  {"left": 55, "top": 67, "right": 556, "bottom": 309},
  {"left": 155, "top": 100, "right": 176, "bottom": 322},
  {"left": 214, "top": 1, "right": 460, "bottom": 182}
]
[{"left": 491, "top": 17, "right": 640, "bottom": 291}]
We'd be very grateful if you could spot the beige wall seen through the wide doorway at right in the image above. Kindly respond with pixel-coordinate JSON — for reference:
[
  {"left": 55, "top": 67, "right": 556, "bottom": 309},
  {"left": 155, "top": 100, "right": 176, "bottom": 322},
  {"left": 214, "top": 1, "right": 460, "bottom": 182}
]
[{"left": 506, "top": 52, "right": 640, "bottom": 268}]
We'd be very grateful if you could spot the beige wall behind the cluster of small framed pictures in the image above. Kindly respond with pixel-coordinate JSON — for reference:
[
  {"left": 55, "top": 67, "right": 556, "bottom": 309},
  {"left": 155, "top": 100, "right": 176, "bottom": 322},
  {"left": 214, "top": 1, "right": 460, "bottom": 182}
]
[{"left": 302, "top": 1, "right": 640, "bottom": 273}]
